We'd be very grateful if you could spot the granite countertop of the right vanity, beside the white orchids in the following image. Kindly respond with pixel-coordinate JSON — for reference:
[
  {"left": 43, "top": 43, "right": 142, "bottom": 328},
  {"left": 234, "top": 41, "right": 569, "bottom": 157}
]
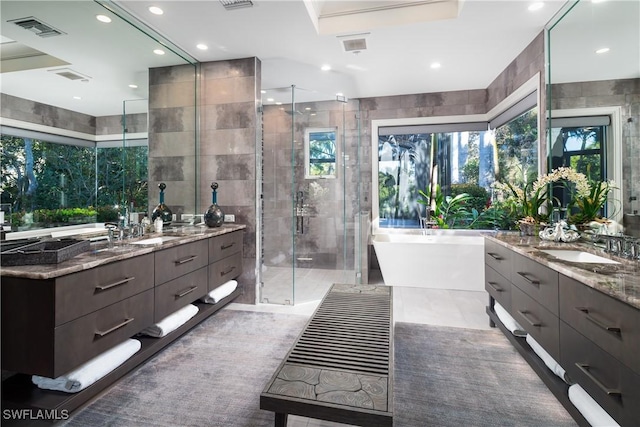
[{"left": 485, "top": 232, "right": 640, "bottom": 309}]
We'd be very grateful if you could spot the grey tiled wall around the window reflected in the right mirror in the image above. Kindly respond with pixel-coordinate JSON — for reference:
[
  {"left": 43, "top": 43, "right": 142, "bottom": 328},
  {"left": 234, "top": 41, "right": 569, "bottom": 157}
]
[{"left": 551, "top": 78, "right": 640, "bottom": 217}]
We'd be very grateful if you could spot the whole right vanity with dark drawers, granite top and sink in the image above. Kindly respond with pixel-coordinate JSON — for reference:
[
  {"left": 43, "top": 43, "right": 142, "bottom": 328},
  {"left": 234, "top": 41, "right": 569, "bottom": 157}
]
[{"left": 485, "top": 233, "right": 640, "bottom": 426}]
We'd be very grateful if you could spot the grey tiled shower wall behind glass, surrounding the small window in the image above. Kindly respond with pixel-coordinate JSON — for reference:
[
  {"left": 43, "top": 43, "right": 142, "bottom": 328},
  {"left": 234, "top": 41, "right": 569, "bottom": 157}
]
[{"left": 263, "top": 101, "right": 360, "bottom": 270}]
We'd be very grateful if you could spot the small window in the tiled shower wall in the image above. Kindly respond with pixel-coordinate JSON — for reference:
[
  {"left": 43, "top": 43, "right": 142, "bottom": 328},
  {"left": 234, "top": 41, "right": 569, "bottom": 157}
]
[{"left": 304, "top": 128, "right": 337, "bottom": 178}]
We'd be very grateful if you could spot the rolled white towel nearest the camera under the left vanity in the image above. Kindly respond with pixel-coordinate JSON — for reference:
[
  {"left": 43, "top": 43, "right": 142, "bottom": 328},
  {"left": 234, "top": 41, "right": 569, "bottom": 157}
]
[{"left": 31, "top": 339, "right": 141, "bottom": 393}]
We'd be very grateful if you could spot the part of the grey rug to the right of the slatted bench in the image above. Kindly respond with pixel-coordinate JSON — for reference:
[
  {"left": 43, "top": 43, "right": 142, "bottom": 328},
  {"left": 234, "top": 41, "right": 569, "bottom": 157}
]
[{"left": 394, "top": 323, "right": 576, "bottom": 427}]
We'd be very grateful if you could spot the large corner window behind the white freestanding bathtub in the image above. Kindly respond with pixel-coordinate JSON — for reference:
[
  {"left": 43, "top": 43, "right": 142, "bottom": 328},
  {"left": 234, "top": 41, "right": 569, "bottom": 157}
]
[{"left": 374, "top": 107, "right": 539, "bottom": 228}]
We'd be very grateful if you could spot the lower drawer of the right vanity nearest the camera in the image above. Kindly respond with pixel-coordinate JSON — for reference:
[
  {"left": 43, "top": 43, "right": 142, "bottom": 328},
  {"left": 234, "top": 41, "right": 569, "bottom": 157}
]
[{"left": 560, "top": 322, "right": 640, "bottom": 426}]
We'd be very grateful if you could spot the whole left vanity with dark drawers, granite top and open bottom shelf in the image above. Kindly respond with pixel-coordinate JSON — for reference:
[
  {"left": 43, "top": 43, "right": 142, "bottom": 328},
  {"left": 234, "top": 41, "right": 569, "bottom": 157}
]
[{"left": 1, "top": 225, "right": 245, "bottom": 422}]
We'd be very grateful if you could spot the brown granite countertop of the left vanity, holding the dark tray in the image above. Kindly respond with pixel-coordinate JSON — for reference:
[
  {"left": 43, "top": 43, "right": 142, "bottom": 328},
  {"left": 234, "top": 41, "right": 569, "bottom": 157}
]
[{"left": 0, "top": 224, "right": 246, "bottom": 280}]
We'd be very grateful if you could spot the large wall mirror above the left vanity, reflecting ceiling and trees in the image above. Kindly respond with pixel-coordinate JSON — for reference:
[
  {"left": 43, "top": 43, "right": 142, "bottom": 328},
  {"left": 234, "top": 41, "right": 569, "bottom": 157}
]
[{"left": 0, "top": 1, "right": 196, "bottom": 234}]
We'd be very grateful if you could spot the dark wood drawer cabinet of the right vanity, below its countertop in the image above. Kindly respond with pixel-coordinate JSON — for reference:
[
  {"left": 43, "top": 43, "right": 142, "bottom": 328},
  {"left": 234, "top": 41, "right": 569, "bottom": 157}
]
[{"left": 485, "top": 239, "right": 640, "bottom": 425}]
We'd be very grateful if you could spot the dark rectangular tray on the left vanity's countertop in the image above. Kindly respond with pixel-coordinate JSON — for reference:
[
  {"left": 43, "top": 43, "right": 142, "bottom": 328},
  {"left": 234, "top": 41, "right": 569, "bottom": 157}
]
[{"left": 0, "top": 239, "right": 91, "bottom": 266}]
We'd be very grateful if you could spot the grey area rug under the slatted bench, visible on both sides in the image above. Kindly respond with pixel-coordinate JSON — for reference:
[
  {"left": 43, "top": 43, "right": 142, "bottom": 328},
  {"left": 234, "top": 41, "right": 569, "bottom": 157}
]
[{"left": 60, "top": 309, "right": 575, "bottom": 427}]
